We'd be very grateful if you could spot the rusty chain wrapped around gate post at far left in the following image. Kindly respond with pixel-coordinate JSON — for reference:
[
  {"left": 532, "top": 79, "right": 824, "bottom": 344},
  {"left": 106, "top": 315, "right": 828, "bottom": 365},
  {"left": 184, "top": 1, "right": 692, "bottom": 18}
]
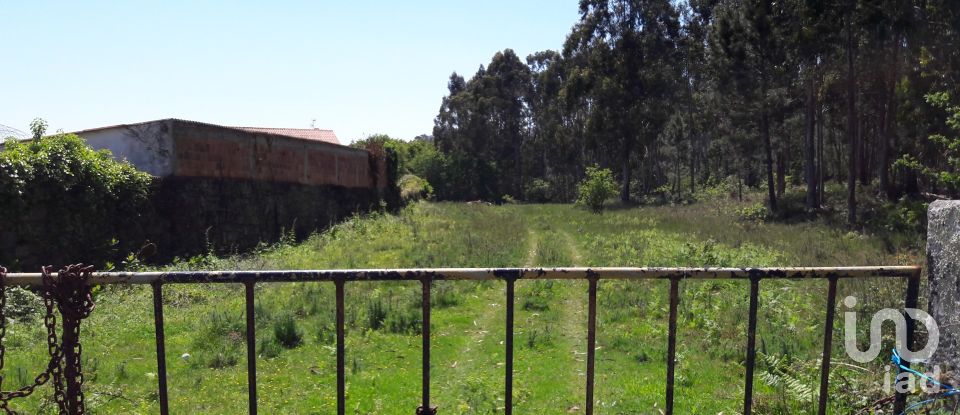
[{"left": 0, "top": 265, "right": 94, "bottom": 415}]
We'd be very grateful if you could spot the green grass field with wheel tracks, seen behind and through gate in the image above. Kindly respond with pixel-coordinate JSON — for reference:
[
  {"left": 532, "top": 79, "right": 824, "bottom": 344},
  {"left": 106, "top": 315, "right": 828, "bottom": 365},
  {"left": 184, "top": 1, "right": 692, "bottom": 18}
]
[{"left": 4, "top": 203, "right": 920, "bottom": 414}]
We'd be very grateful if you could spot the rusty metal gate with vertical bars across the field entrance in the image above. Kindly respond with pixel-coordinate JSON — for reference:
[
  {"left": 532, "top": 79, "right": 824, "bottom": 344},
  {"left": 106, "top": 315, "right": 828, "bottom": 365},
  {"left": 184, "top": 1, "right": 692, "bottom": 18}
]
[{"left": 5, "top": 266, "right": 921, "bottom": 415}]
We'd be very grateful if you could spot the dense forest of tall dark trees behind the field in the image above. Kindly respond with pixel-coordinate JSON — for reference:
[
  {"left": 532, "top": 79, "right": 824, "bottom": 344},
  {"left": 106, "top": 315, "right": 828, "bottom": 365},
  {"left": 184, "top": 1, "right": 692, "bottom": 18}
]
[{"left": 370, "top": 0, "right": 960, "bottom": 223}]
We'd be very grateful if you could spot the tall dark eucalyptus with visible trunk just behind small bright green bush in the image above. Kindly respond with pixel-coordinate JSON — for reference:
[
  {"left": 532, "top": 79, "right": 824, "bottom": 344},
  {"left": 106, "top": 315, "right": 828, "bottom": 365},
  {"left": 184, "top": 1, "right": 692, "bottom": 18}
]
[{"left": 568, "top": 0, "right": 680, "bottom": 202}]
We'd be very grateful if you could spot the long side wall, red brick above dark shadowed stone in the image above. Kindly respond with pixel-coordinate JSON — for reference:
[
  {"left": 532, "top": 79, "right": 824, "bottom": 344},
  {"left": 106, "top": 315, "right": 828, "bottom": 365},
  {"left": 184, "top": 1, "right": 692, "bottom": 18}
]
[{"left": 144, "top": 120, "right": 387, "bottom": 259}]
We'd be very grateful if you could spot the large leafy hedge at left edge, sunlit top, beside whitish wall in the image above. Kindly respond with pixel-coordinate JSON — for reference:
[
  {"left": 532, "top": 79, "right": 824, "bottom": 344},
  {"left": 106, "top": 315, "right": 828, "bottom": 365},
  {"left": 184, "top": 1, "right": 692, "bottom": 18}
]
[{"left": 0, "top": 131, "right": 151, "bottom": 269}]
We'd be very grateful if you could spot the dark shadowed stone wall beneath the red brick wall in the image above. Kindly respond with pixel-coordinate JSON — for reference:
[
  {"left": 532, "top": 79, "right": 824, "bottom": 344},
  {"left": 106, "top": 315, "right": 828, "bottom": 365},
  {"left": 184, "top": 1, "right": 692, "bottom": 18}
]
[{"left": 148, "top": 177, "right": 380, "bottom": 261}]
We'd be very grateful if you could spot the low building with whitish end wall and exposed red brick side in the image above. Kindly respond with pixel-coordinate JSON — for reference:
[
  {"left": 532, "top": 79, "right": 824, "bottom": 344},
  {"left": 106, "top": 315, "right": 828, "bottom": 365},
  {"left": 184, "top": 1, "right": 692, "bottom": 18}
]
[{"left": 75, "top": 119, "right": 384, "bottom": 188}]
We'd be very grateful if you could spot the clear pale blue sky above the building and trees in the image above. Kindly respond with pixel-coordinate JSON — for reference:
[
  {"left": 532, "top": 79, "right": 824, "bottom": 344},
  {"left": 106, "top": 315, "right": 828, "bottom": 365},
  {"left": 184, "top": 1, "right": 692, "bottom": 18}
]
[{"left": 0, "top": 0, "right": 578, "bottom": 142}]
